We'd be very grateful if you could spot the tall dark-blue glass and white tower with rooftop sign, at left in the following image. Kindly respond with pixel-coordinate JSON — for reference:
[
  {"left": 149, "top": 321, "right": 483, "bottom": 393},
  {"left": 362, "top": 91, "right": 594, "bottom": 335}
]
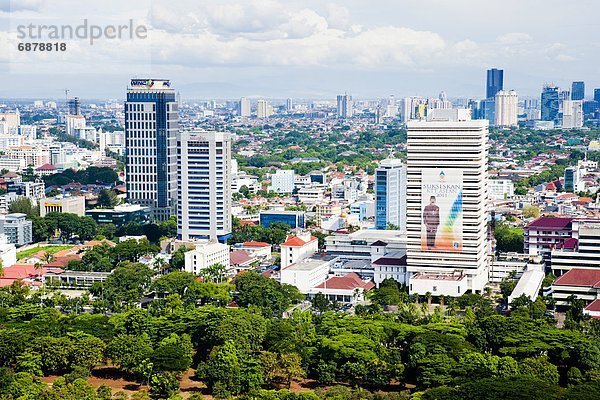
[{"left": 125, "top": 79, "right": 179, "bottom": 221}]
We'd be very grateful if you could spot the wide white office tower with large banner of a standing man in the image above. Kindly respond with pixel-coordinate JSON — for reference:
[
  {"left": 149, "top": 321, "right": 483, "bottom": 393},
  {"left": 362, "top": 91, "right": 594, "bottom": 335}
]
[{"left": 407, "top": 110, "right": 488, "bottom": 296}]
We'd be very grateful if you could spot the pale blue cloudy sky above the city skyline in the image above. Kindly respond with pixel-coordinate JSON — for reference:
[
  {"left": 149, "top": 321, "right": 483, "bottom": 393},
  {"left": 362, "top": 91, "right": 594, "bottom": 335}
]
[{"left": 0, "top": 0, "right": 600, "bottom": 99}]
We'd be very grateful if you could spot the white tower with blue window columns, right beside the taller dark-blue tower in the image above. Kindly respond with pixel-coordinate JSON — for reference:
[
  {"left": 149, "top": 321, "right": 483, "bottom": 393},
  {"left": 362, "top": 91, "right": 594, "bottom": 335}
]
[{"left": 177, "top": 131, "right": 231, "bottom": 241}]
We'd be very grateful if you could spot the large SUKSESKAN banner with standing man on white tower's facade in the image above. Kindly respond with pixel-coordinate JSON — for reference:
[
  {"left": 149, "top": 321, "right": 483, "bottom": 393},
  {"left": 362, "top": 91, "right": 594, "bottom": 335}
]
[{"left": 421, "top": 168, "right": 463, "bottom": 252}]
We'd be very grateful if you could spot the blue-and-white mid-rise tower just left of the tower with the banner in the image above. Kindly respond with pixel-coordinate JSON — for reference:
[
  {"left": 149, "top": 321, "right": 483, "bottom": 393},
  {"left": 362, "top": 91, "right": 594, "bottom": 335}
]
[{"left": 375, "top": 158, "right": 406, "bottom": 232}]
